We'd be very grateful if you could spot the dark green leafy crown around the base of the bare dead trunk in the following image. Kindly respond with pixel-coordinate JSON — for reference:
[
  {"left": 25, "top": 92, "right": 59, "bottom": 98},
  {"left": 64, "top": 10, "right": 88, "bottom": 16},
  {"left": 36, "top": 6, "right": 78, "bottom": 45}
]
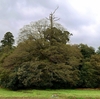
[{"left": 43, "top": 27, "right": 71, "bottom": 44}]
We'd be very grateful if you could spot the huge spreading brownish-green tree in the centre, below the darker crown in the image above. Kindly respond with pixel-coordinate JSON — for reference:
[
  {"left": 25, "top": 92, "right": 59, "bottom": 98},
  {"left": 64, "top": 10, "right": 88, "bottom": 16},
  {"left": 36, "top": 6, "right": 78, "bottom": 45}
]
[{"left": 0, "top": 31, "right": 82, "bottom": 90}]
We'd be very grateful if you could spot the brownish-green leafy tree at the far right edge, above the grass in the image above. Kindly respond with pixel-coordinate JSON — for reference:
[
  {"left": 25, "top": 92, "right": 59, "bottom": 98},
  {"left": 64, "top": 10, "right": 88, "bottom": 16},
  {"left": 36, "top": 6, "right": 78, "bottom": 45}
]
[{"left": 79, "top": 54, "right": 100, "bottom": 88}]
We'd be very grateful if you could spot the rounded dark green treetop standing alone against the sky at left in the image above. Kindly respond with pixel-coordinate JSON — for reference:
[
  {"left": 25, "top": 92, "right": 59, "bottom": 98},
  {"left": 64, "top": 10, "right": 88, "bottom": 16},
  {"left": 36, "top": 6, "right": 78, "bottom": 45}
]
[{"left": 1, "top": 32, "right": 14, "bottom": 47}]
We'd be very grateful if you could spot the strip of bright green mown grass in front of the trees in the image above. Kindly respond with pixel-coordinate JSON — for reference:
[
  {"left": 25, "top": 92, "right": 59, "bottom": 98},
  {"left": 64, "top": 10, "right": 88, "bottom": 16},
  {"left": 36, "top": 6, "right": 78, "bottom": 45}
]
[{"left": 0, "top": 88, "right": 100, "bottom": 99}]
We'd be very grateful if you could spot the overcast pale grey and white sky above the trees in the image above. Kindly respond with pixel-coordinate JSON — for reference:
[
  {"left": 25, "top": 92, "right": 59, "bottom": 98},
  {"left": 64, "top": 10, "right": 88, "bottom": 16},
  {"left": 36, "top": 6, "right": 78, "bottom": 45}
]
[{"left": 0, "top": 0, "right": 100, "bottom": 48}]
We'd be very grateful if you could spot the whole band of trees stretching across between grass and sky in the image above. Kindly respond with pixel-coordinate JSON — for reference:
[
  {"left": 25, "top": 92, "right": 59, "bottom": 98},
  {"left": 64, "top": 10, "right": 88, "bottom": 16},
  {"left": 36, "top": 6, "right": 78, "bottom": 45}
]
[{"left": 0, "top": 20, "right": 100, "bottom": 90}]
